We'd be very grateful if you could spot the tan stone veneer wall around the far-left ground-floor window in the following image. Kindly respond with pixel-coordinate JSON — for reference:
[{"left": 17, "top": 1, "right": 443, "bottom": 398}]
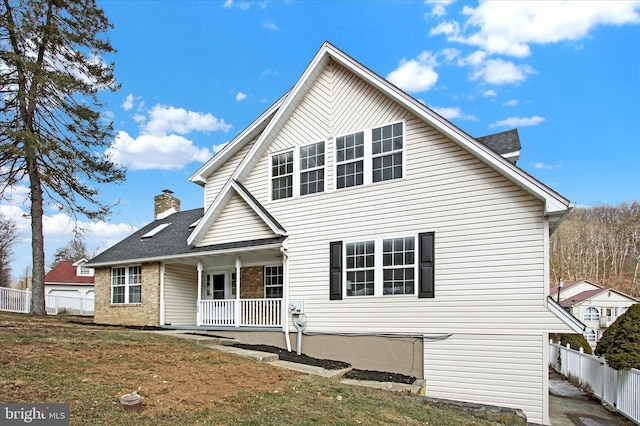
[{"left": 93, "top": 263, "right": 161, "bottom": 326}]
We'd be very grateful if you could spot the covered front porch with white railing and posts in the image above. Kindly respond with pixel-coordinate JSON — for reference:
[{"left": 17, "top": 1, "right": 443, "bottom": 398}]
[{"left": 160, "top": 241, "right": 288, "bottom": 331}]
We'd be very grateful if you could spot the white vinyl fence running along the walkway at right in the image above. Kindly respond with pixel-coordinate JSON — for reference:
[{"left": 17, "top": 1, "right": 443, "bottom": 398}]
[{"left": 549, "top": 342, "right": 640, "bottom": 424}]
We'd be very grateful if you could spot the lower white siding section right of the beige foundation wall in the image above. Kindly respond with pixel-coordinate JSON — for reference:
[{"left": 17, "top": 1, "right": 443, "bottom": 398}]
[{"left": 424, "top": 336, "right": 548, "bottom": 424}]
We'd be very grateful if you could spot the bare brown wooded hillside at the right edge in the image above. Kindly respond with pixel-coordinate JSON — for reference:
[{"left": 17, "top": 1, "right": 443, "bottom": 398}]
[{"left": 550, "top": 201, "right": 640, "bottom": 297}]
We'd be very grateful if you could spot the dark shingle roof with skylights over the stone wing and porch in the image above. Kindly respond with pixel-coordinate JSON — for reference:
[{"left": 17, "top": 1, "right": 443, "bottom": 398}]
[{"left": 86, "top": 209, "right": 285, "bottom": 267}]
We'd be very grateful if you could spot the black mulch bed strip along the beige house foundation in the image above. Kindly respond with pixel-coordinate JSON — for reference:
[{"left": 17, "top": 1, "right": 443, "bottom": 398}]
[{"left": 232, "top": 343, "right": 416, "bottom": 385}]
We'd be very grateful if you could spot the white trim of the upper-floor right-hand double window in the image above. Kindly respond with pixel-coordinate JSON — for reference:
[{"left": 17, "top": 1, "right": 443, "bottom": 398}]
[{"left": 336, "top": 120, "right": 407, "bottom": 191}]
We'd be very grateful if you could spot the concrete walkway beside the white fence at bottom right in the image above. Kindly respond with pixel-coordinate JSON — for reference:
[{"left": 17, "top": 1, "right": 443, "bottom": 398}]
[{"left": 549, "top": 370, "right": 634, "bottom": 426}]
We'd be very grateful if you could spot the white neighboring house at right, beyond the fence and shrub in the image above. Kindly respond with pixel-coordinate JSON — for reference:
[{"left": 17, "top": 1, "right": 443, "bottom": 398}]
[{"left": 550, "top": 280, "right": 640, "bottom": 347}]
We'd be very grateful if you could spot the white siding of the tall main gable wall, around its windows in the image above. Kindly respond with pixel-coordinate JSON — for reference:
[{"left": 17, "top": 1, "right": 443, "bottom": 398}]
[{"left": 202, "top": 57, "right": 571, "bottom": 423}]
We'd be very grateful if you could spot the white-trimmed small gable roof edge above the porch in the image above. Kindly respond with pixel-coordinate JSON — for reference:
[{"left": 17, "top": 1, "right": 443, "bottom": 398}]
[{"left": 187, "top": 179, "right": 287, "bottom": 244}]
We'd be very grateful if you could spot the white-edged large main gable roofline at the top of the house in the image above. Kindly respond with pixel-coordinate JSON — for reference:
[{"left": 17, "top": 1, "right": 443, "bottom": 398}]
[{"left": 190, "top": 42, "right": 573, "bottom": 231}]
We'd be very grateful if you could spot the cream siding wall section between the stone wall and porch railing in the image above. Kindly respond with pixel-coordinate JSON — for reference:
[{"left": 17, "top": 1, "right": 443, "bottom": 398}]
[{"left": 164, "top": 265, "right": 198, "bottom": 326}]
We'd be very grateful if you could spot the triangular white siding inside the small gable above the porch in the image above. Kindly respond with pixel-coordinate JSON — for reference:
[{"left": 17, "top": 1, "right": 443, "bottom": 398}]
[{"left": 198, "top": 194, "right": 275, "bottom": 246}]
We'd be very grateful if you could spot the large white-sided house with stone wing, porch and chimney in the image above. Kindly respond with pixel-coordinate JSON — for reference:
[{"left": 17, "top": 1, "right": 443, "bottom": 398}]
[{"left": 90, "top": 43, "right": 582, "bottom": 424}]
